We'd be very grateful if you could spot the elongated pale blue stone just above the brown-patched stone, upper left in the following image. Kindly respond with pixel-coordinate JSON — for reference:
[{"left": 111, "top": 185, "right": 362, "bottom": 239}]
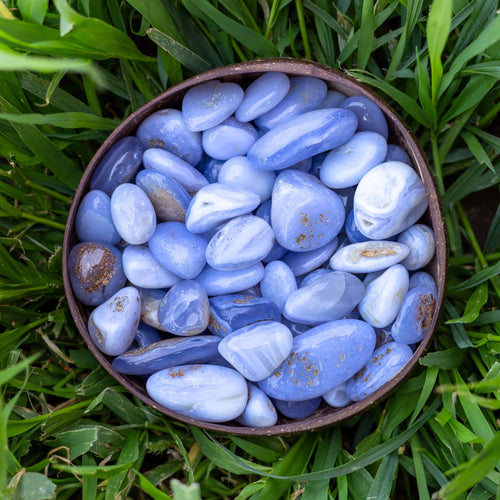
[{"left": 142, "top": 148, "right": 208, "bottom": 193}]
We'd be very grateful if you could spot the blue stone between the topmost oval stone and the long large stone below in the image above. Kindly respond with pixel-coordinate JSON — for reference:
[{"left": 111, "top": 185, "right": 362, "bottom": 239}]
[{"left": 255, "top": 76, "right": 328, "bottom": 129}]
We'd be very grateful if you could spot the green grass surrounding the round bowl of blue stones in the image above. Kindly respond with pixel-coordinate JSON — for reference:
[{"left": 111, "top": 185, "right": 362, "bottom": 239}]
[{"left": 0, "top": 0, "right": 500, "bottom": 500}]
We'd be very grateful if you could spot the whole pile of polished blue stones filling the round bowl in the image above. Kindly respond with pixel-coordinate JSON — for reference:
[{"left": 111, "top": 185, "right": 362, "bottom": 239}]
[{"left": 69, "top": 72, "right": 436, "bottom": 427}]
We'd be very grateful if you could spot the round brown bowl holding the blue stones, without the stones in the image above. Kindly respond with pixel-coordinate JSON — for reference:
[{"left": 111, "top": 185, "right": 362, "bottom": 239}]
[{"left": 63, "top": 58, "right": 447, "bottom": 436}]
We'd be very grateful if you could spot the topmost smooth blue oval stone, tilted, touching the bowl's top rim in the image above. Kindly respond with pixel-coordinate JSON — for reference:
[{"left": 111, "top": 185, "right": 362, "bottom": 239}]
[{"left": 234, "top": 71, "right": 290, "bottom": 122}]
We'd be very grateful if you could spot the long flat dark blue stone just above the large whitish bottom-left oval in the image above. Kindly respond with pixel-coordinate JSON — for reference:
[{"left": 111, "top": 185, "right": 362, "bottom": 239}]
[{"left": 115, "top": 335, "right": 220, "bottom": 375}]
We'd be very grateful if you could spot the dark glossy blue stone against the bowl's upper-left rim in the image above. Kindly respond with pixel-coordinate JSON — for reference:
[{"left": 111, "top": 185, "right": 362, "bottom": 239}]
[{"left": 90, "top": 136, "right": 144, "bottom": 196}]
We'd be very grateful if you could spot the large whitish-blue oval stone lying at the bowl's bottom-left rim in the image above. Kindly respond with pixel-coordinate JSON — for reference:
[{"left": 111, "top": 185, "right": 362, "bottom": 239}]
[{"left": 146, "top": 364, "right": 248, "bottom": 422}]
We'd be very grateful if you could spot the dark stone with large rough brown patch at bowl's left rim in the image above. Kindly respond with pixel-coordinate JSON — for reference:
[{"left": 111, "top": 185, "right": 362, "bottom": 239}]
[{"left": 68, "top": 242, "right": 126, "bottom": 306}]
